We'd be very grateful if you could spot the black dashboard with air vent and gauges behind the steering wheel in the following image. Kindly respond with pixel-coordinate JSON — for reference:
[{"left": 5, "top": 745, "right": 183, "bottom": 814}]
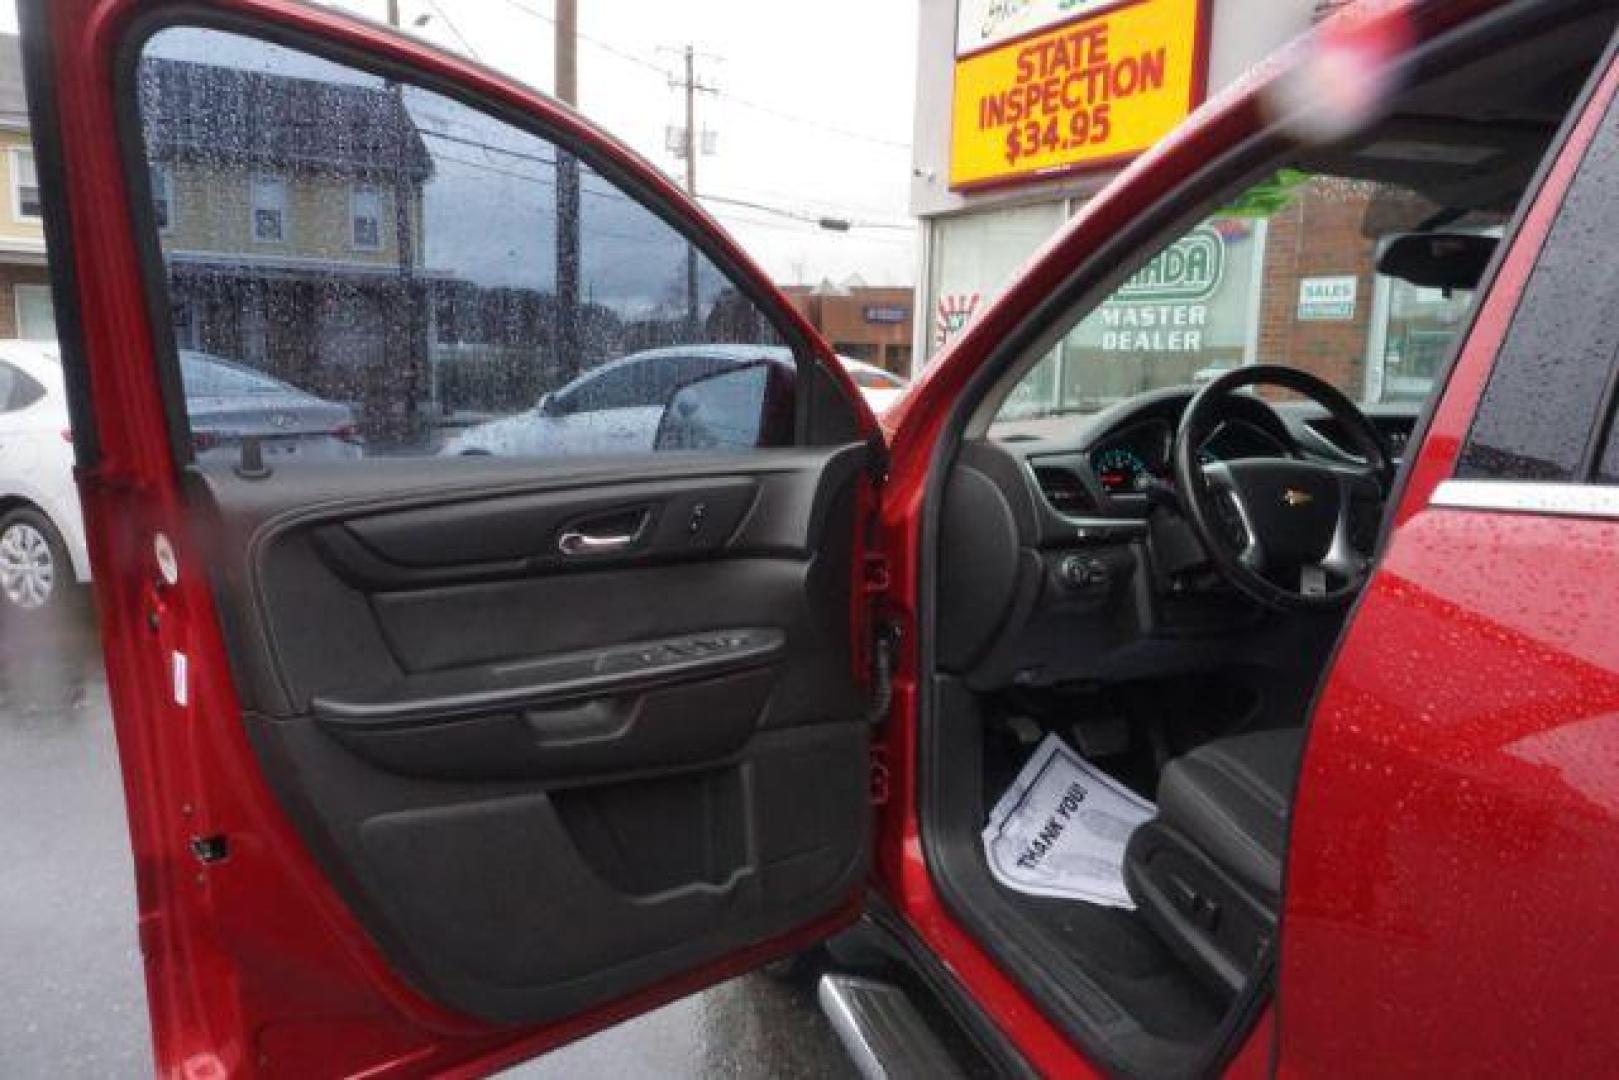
[{"left": 936, "top": 387, "right": 1420, "bottom": 688}]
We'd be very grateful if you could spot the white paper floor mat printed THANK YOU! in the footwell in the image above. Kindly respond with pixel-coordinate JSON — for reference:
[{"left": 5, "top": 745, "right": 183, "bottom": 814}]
[{"left": 984, "top": 735, "right": 1158, "bottom": 908}]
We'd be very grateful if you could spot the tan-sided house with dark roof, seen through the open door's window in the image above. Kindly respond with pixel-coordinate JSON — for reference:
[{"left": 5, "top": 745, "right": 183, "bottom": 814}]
[{"left": 138, "top": 57, "right": 442, "bottom": 426}]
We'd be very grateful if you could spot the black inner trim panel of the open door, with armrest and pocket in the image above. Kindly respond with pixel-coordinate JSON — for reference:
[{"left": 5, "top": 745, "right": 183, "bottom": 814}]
[{"left": 177, "top": 445, "right": 868, "bottom": 1023}]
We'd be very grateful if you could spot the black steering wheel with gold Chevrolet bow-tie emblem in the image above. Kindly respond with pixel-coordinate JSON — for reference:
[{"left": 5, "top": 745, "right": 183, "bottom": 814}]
[{"left": 1174, "top": 364, "right": 1392, "bottom": 610}]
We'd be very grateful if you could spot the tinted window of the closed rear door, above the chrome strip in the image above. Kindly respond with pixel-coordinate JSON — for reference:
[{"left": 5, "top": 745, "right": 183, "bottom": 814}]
[{"left": 1457, "top": 86, "right": 1619, "bottom": 483}]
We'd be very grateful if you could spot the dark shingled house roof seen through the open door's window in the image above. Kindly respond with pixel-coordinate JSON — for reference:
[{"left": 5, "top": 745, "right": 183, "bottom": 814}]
[{"left": 139, "top": 57, "right": 432, "bottom": 181}]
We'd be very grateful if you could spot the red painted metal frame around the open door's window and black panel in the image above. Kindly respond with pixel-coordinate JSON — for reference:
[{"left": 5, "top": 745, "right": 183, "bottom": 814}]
[{"left": 26, "top": 0, "right": 876, "bottom": 1077}]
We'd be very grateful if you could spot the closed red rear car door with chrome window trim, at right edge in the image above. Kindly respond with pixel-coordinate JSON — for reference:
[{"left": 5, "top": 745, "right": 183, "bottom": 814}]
[{"left": 1277, "top": 38, "right": 1619, "bottom": 1075}]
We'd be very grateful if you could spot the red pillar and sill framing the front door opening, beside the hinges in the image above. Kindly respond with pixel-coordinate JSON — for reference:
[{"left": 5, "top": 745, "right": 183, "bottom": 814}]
[{"left": 877, "top": 2, "right": 1498, "bottom": 1075}]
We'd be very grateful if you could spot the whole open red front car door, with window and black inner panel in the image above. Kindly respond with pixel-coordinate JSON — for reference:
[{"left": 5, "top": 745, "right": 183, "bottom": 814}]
[{"left": 21, "top": 0, "right": 881, "bottom": 1077}]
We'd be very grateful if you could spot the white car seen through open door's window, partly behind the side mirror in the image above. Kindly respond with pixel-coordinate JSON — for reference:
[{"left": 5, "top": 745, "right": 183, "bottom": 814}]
[{"left": 440, "top": 345, "right": 907, "bottom": 457}]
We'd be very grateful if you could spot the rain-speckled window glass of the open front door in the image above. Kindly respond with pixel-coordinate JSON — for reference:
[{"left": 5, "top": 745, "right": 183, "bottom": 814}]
[{"left": 134, "top": 28, "right": 797, "bottom": 461}]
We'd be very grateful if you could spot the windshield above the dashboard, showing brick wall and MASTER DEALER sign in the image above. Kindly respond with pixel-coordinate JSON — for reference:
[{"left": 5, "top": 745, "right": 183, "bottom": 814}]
[{"left": 997, "top": 170, "right": 1499, "bottom": 419}]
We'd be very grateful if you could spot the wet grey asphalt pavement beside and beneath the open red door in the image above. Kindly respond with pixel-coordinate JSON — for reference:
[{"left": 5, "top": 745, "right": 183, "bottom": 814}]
[{"left": 0, "top": 614, "right": 853, "bottom": 1080}]
